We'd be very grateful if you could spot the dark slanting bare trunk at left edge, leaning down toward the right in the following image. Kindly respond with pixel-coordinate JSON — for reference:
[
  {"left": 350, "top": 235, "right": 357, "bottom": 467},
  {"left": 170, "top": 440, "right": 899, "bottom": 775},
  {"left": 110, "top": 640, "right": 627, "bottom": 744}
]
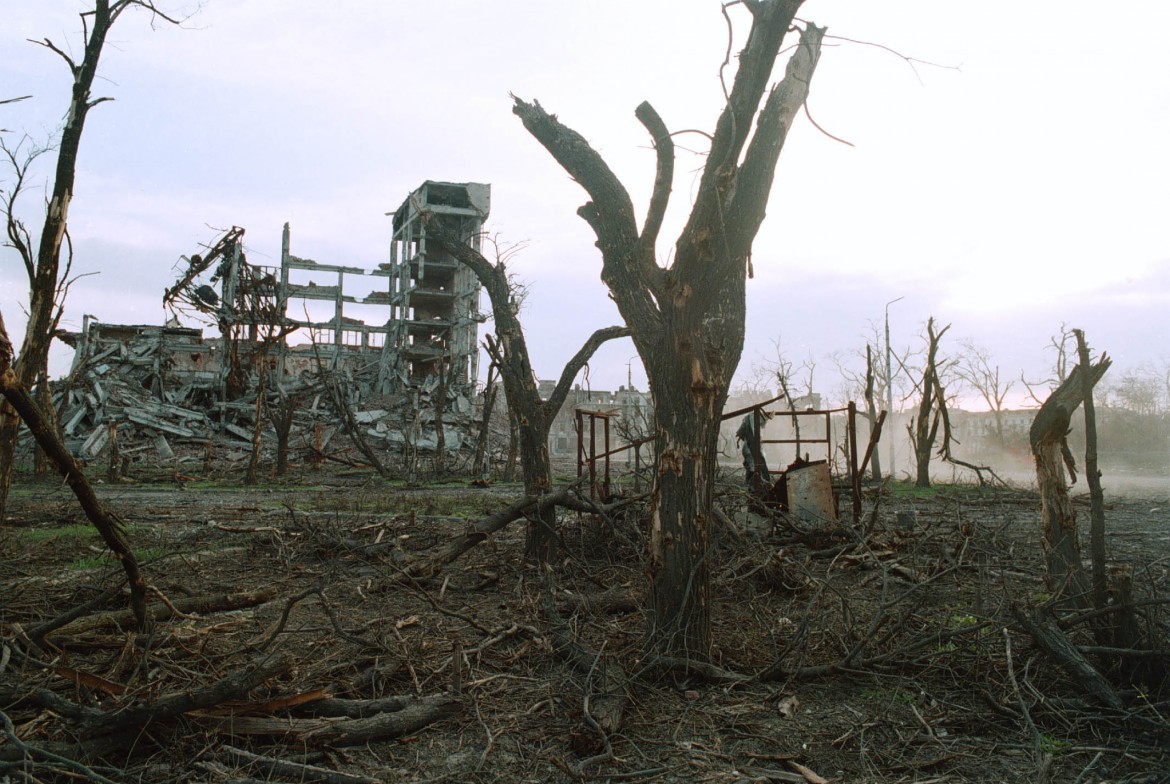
[{"left": 0, "top": 314, "right": 147, "bottom": 630}]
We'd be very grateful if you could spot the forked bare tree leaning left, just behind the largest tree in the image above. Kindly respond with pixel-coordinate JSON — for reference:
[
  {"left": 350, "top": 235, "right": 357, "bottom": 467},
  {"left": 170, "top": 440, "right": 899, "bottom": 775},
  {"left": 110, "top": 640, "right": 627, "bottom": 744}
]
[{"left": 426, "top": 222, "right": 629, "bottom": 563}]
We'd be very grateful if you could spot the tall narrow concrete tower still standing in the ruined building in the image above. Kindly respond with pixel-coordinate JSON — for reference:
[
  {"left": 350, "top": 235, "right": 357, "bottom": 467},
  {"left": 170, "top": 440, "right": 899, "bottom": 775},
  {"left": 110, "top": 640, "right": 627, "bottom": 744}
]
[{"left": 380, "top": 180, "right": 491, "bottom": 390}]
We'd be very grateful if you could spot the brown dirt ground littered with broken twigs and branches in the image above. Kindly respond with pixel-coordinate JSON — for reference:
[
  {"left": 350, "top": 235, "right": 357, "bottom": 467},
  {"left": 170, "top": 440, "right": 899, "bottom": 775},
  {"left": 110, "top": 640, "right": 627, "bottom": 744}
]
[{"left": 0, "top": 461, "right": 1170, "bottom": 784}]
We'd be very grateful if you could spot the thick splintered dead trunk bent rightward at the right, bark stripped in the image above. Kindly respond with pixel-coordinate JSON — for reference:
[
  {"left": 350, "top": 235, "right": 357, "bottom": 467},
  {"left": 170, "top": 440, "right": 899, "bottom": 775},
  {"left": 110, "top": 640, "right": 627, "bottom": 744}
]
[{"left": 1028, "top": 355, "right": 1113, "bottom": 606}]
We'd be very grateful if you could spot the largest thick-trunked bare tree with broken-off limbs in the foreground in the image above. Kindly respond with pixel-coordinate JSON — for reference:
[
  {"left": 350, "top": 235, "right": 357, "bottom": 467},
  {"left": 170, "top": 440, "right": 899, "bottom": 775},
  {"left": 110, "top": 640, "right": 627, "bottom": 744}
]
[{"left": 512, "top": 0, "right": 825, "bottom": 659}]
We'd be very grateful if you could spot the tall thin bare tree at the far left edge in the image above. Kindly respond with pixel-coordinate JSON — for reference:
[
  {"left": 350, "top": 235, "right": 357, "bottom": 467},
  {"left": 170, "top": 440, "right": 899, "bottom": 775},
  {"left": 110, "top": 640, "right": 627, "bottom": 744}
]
[{"left": 0, "top": 0, "right": 179, "bottom": 515}]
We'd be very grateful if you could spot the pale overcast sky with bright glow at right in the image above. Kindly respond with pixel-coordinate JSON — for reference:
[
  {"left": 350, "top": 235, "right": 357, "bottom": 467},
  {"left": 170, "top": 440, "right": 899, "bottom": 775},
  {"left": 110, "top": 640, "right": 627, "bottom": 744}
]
[{"left": 0, "top": 0, "right": 1170, "bottom": 411}]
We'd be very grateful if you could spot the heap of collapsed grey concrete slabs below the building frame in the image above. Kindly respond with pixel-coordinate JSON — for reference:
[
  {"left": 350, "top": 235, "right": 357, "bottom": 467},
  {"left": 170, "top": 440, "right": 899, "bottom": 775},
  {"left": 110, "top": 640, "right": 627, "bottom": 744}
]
[{"left": 44, "top": 321, "right": 476, "bottom": 472}]
